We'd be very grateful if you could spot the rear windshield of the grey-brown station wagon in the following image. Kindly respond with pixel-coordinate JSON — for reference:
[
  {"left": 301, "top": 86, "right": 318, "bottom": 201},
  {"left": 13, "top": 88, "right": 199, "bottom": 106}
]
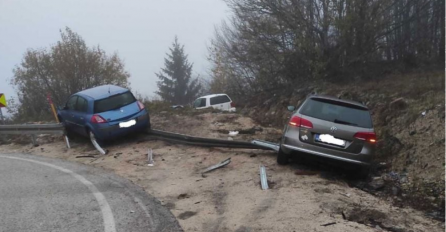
[{"left": 299, "top": 98, "right": 372, "bottom": 128}]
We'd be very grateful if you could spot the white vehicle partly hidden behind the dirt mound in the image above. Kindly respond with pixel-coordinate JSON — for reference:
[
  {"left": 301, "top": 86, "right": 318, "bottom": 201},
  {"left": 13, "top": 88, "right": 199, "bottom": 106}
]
[{"left": 194, "top": 93, "right": 235, "bottom": 112}]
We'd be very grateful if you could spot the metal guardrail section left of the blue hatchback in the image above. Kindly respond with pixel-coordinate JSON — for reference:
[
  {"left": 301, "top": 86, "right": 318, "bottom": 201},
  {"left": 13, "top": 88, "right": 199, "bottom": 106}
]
[{"left": 0, "top": 124, "right": 65, "bottom": 135}]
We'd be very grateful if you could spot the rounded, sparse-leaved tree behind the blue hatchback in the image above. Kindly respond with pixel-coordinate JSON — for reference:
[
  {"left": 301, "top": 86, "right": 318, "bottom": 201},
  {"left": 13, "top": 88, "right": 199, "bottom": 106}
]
[{"left": 11, "top": 28, "right": 130, "bottom": 120}]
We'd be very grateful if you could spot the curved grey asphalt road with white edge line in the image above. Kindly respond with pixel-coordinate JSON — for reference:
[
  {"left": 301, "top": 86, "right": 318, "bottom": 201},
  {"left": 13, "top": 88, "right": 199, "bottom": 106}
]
[{"left": 0, "top": 154, "right": 182, "bottom": 232}]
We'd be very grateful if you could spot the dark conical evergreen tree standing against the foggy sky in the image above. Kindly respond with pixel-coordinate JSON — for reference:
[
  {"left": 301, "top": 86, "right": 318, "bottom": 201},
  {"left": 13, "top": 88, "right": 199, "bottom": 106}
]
[{"left": 156, "top": 37, "right": 201, "bottom": 105}]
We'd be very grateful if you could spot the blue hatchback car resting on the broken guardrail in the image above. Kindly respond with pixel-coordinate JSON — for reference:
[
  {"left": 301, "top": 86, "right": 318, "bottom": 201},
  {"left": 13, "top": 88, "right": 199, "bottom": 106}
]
[{"left": 58, "top": 85, "right": 150, "bottom": 141}]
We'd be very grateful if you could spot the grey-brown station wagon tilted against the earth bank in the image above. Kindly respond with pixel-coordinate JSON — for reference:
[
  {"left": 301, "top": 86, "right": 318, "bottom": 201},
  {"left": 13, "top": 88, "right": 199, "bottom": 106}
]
[{"left": 277, "top": 95, "right": 376, "bottom": 174}]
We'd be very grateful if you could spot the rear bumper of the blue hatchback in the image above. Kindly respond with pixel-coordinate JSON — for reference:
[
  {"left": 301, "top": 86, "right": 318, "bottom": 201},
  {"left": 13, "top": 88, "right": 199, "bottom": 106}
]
[{"left": 94, "top": 110, "right": 150, "bottom": 140}]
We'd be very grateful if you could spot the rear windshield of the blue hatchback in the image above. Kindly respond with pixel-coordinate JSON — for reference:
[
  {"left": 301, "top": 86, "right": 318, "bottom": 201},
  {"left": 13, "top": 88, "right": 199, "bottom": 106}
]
[{"left": 94, "top": 92, "right": 136, "bottom": 113}]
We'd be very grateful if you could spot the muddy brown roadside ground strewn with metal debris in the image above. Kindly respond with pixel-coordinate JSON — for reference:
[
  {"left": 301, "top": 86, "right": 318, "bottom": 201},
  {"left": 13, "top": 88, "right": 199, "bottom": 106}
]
[{"left": 0, "top": 112, "right": 445, "bottom": 232}]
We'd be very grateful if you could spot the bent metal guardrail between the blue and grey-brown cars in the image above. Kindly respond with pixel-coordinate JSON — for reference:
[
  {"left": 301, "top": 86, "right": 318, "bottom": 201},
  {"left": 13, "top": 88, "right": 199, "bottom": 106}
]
[{"left": 149, "top": 129, "right": 278, "bottom": 150}]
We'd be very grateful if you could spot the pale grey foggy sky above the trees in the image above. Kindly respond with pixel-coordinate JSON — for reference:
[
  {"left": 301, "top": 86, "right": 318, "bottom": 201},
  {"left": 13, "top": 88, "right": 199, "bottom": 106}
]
[{"left": 0, "top": 0, "right": 230, "bottom": 109}]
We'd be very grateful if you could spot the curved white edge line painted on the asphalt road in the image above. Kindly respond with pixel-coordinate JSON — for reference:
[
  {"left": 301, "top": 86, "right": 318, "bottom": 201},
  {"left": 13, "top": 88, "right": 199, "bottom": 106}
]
[{"left": 0, "top": 155, "right": 116, "bottom": 232}]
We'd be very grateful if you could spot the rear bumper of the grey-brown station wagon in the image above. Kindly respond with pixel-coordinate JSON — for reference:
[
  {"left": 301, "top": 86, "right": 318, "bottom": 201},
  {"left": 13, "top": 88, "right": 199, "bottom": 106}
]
[{"left": 280, "top": 130, "right": 373, "bottom": 166}]
